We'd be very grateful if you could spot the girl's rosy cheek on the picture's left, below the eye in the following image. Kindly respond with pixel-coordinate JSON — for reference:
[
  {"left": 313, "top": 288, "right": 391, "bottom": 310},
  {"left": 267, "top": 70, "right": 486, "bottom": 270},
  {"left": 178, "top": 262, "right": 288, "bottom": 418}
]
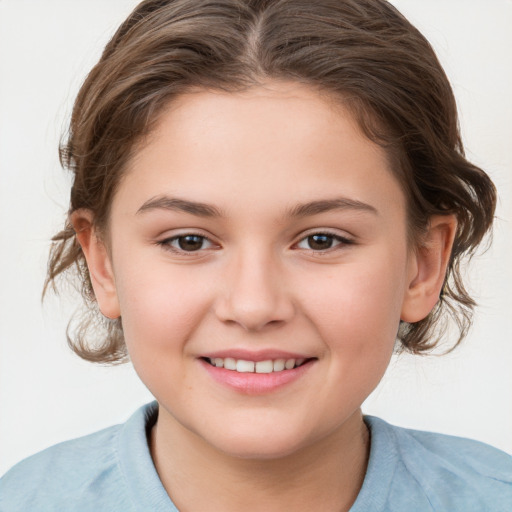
[{"left": 113, "top": 260, "right": 215, "bottom": 402}]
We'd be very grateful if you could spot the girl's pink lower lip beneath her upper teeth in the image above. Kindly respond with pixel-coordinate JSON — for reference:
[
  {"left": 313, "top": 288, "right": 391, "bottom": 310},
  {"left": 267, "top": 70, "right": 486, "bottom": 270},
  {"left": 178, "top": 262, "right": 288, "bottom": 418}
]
[{"left": 199, "top": 359, "right": 315, "bottom": 395}]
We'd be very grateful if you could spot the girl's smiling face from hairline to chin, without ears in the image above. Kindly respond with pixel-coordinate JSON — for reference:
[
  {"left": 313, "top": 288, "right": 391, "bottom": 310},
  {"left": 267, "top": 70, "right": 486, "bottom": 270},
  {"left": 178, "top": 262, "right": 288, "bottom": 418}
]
[{"left": 99, "top": 83, "right": 416, "bottom": 458}]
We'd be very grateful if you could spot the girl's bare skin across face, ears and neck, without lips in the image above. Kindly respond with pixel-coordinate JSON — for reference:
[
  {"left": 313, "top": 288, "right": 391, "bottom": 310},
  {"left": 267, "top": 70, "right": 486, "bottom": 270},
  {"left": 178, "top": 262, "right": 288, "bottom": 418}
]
[{"left": 72, "top": 82, "right": 456, "bottom": 512}]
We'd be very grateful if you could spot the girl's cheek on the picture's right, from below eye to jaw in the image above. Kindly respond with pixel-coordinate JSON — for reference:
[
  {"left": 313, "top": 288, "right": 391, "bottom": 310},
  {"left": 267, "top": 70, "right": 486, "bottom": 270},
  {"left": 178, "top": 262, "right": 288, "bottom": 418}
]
[{"left": 309, "top": 260, "right": 401, "bottom": 421}]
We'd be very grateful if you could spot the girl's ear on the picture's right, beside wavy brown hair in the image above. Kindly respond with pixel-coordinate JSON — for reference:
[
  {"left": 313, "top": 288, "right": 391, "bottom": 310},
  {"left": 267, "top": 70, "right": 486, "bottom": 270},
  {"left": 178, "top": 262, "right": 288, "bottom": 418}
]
[{"left": 400, "top": 215, "right": 457, "bottom": 323}]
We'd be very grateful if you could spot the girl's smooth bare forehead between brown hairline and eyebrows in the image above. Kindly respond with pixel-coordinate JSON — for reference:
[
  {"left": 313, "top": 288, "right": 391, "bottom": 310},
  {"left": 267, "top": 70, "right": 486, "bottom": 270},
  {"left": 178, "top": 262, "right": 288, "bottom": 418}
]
[{"left": 120, "top": 82, "right": 403, "bottom": 220}]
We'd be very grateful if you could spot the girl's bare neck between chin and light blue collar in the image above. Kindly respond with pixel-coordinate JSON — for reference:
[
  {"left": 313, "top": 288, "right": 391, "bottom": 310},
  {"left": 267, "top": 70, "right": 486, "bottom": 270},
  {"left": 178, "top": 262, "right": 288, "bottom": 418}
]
[{"left": 150, "top": 408, "right": 370, "bottom": 512}]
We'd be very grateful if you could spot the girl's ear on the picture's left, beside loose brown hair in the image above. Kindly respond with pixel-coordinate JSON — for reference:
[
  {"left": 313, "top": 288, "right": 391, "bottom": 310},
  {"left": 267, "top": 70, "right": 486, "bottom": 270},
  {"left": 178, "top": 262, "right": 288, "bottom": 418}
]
[{"left": 70, "top": 209, "right": 121, "bottom": 318}]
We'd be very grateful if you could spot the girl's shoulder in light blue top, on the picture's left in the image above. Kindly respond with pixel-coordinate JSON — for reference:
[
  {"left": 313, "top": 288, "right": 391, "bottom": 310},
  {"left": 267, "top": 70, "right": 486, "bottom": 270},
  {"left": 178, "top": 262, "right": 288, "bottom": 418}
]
[{"left": 0, "top": 404, "right": 162, "bottom": 512}]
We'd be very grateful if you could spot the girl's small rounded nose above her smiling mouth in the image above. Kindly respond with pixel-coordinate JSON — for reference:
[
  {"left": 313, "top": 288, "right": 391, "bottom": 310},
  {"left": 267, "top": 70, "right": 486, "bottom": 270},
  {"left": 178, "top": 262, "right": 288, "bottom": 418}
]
[{"left": 215, "top": 250, "right": 295, "bottom": 331}]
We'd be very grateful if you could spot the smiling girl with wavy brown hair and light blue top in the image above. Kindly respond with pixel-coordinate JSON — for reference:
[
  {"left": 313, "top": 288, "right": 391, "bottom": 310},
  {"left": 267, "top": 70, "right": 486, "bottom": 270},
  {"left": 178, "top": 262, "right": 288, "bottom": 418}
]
[{"left": 0, "top": 0, "right": 512, "bottom": 511}]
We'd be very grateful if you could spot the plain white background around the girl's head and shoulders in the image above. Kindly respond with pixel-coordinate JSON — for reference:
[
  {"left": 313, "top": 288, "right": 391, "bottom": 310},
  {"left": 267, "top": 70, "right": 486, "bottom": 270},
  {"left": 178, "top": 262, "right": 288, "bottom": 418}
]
[{"left": 0, "top": 0, "right": 512, "bottom": 474}]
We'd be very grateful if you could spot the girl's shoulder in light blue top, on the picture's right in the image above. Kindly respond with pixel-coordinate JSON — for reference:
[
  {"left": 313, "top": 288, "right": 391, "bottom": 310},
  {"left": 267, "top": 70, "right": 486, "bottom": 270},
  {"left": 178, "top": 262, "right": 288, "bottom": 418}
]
[{"left": 366, "top": 417, "right": 512, "bottom": 512}]
